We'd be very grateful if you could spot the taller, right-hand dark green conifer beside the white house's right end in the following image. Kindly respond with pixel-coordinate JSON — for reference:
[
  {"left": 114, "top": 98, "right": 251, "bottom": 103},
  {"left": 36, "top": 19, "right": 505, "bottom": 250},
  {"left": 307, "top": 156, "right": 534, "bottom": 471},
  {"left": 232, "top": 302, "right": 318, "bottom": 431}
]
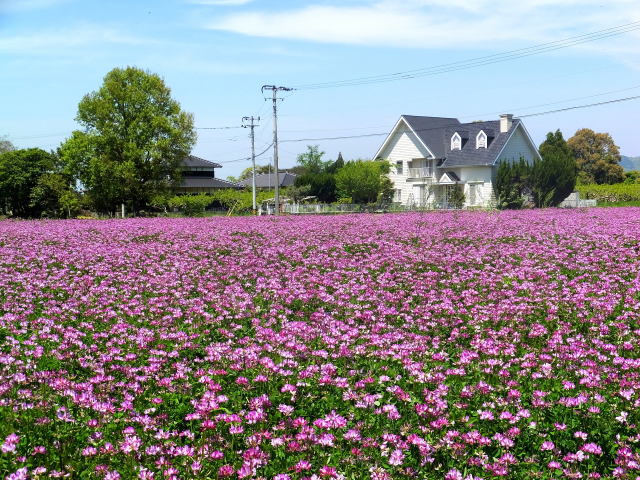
[{"left": 530, "top": 130, "right": 577, "bottom": 207}]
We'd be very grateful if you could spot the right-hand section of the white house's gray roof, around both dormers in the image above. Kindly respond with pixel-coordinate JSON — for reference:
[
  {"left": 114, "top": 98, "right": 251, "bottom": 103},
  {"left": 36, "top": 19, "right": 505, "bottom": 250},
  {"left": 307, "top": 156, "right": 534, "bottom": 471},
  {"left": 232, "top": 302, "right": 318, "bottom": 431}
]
[{"left": 440, "top": 119, "right": 520, "bottom": 168}]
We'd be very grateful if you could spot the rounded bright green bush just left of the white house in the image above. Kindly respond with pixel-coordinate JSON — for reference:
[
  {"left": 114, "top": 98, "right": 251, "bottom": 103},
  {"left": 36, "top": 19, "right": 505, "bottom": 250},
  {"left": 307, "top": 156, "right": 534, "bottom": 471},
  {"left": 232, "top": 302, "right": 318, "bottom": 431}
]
[{"left": 336, "top": 160, "right": 391, "bottom": 203}]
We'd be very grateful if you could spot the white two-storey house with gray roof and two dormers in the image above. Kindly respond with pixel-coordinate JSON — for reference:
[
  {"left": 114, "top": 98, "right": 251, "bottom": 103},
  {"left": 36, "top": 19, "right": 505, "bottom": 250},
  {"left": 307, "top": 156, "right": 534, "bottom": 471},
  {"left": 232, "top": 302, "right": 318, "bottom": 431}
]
[{"left": 374, "top": 114, "right": 540, "bottom": 208}]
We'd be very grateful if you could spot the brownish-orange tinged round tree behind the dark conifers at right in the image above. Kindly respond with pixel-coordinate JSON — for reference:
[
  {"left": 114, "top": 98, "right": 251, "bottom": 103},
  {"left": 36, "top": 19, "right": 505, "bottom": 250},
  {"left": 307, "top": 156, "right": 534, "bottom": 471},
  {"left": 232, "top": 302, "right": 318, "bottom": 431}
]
[{"left": 567, "top": 128, "right": 624, "bottom": 184}]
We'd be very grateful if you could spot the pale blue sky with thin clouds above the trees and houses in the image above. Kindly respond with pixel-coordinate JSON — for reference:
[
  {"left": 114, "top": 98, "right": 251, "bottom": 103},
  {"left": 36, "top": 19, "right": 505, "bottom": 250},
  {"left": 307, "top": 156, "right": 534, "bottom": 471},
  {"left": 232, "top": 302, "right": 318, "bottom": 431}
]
[{"left": 0, "top": 0, "right": 640, "bottom": 178}]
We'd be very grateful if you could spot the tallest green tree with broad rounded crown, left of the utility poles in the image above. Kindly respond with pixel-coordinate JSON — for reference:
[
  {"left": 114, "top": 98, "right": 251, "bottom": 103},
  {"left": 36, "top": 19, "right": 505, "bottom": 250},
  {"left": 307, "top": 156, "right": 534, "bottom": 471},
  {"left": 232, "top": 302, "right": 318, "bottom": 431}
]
[{"left": 60, "top": 67, "right": 196, "bottom": 212}]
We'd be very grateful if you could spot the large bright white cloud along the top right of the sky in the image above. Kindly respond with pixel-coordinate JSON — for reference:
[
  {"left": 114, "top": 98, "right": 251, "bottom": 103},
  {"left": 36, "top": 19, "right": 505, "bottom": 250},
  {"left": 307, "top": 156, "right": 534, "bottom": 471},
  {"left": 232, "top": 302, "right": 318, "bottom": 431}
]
[{"left": 207, "top": 0, "right": 640, "bottom": 50}]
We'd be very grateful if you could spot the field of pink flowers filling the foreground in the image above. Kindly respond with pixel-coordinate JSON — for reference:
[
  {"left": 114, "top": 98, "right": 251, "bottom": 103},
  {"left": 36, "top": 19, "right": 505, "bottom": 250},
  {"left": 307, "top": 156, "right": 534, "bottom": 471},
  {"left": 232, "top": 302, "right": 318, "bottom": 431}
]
[{"left": 0, "top": 208, "right": 640, "bottom": 480}]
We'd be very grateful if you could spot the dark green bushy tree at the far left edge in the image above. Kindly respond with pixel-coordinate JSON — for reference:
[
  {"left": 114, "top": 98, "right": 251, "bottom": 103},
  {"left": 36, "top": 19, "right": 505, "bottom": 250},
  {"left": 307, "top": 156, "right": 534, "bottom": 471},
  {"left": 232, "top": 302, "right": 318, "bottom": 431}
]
[{"left": 0, "top": 148, "right": 56, "bottom": 217}]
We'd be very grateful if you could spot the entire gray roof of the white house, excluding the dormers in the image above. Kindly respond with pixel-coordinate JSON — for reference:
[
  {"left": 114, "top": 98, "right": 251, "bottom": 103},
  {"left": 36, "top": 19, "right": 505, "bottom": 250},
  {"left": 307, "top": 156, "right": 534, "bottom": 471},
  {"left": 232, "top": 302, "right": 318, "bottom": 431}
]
[{"left": 402, "top": 115, "right": 520, "bottom": 168}]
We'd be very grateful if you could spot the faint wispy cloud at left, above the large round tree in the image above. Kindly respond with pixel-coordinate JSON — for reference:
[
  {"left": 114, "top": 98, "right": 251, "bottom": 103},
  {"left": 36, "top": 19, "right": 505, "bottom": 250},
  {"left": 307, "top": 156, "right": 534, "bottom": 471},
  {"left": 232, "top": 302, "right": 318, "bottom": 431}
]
[{"left": 0, "top": 25, "right": 157, "bottom": 54}]
